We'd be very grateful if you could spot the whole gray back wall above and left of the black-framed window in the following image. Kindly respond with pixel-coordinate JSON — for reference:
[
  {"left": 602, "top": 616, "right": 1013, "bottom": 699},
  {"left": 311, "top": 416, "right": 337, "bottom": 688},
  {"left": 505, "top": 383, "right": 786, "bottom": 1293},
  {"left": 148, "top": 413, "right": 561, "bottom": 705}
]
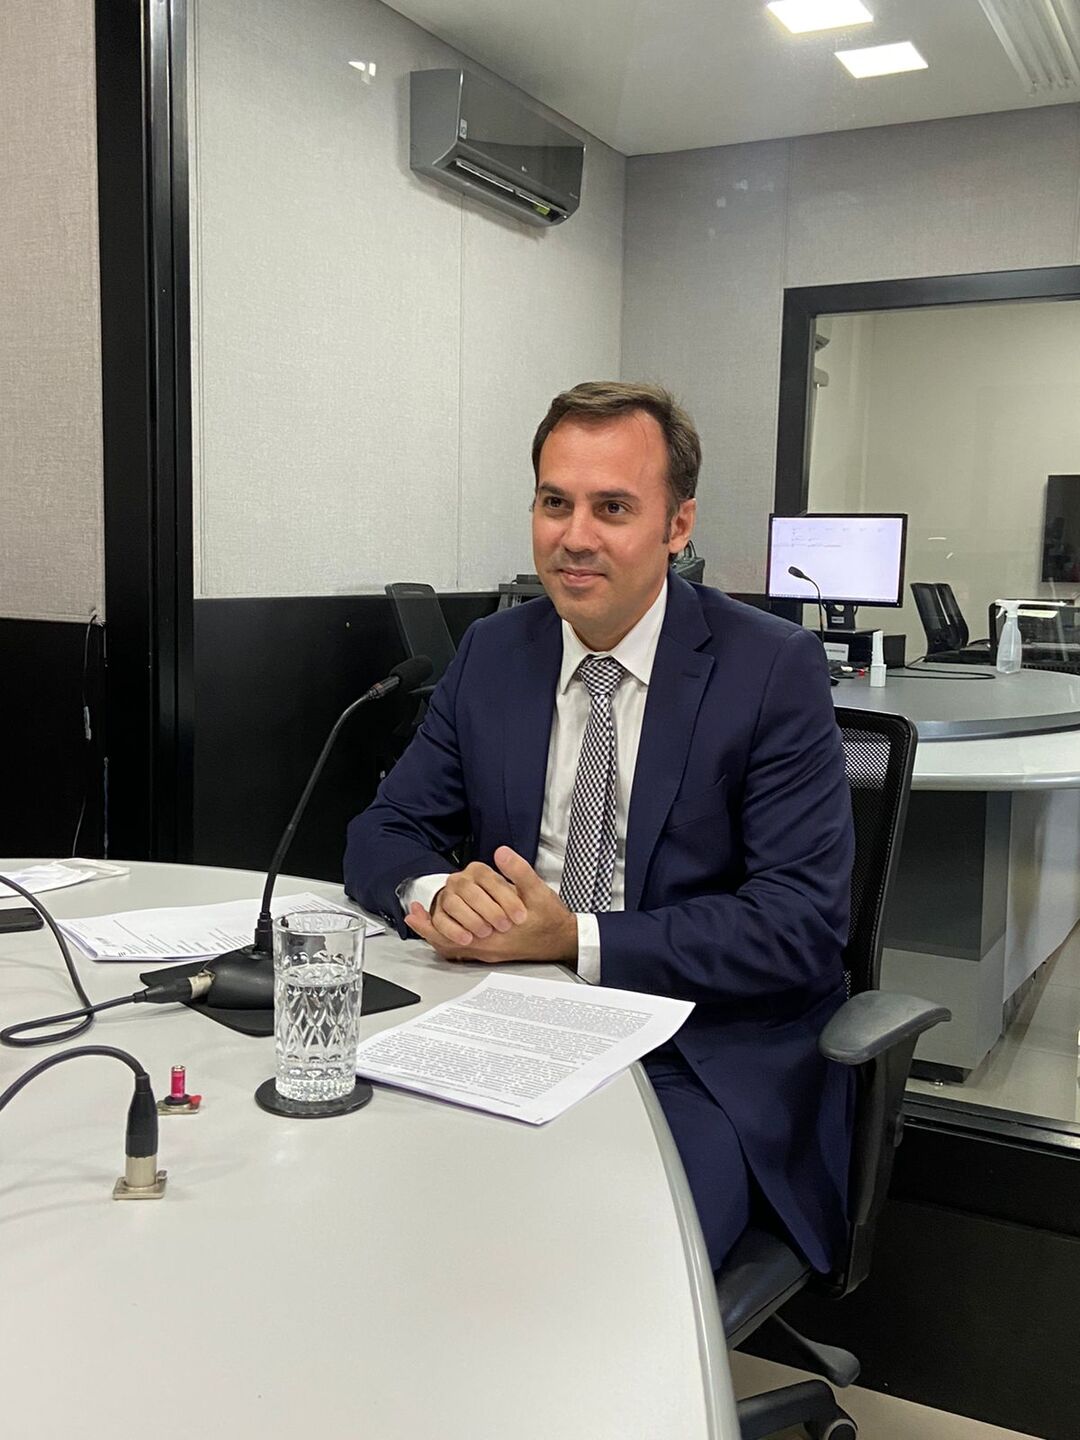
[{"left": 624, "top": 105, "right": 1080, "bottom": 590}]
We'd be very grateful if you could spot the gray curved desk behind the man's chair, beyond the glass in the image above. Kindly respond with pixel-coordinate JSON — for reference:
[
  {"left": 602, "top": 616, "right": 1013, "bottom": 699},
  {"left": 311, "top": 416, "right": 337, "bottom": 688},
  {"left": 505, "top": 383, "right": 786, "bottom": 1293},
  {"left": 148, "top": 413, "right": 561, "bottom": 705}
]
[{"left": 832, "top": 665, "right": 1080, "bottom": 1079}]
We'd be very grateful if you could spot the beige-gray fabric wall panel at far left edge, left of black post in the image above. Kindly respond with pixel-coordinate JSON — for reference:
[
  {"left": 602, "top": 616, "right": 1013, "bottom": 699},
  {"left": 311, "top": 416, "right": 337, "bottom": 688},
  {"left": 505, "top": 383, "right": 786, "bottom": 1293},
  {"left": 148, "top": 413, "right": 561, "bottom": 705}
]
[{"left": 0, "top": 0, "right": 105, "bottom": 621}]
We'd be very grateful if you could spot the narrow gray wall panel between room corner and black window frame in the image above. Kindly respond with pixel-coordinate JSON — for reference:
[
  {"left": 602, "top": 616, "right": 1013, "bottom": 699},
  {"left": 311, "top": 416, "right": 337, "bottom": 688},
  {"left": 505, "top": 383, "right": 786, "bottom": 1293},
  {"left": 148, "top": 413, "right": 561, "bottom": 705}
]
[{"left": 622, "top": 141, "right": 788, "bottom": 590}]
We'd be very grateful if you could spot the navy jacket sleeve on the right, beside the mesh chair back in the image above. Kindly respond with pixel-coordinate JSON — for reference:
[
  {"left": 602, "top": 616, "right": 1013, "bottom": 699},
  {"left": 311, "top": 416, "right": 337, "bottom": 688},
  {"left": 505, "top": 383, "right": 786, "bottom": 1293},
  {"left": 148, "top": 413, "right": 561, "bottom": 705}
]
[{"left": 599, "top": 629, "right": 854, "bottom": 1005}]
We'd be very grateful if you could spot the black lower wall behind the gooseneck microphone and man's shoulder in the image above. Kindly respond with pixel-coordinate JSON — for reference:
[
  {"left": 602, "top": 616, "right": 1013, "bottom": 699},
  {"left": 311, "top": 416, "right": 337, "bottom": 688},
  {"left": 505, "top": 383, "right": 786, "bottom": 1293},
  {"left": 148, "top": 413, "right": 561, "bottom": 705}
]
[{"left": 192, "top": 593, "right": 498, "bottom": 880}]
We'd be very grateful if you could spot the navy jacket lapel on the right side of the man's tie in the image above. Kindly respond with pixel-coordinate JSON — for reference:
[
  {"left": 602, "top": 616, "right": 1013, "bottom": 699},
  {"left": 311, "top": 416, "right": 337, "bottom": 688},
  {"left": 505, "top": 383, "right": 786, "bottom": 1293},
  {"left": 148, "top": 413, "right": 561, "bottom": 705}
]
[{"left": 625, "top": 576, "right": 713, "bottom": 910}]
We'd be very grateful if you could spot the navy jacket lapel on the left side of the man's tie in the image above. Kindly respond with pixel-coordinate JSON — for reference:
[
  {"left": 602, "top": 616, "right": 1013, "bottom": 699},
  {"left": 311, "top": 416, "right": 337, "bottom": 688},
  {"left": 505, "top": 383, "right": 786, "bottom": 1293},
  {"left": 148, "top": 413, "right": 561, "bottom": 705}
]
[{"left": 503, "top": 599, "right": 563, "bottom": 865}]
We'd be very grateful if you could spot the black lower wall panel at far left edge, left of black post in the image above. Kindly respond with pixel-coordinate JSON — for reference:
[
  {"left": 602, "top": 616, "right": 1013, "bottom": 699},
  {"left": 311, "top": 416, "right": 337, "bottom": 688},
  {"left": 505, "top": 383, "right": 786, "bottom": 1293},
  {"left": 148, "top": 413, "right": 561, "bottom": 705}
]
[{"left": 0, "top": 619, "right": 105, "bottom": 857}]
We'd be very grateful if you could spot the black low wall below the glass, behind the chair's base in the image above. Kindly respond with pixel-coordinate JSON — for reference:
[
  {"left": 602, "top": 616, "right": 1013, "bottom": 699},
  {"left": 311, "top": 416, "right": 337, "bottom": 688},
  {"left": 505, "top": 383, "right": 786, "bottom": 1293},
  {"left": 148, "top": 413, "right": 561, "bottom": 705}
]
[{"left": 744, "top": 1096, "right": 1080, "bottom": 1440}]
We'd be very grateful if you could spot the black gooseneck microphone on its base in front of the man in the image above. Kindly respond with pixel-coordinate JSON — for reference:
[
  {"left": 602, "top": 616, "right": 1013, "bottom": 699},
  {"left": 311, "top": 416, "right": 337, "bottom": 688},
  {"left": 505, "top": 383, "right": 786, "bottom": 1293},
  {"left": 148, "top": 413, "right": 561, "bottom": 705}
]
[{"left": 146, "top": 655, "right": 431, "bottom": 1009}]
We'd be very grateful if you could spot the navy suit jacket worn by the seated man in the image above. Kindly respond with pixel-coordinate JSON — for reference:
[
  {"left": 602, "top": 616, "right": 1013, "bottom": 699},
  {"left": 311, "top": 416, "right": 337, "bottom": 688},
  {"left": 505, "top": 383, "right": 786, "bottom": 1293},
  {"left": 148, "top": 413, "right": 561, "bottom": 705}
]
[{"left": 344, "top": 576, "right": 852, "bottom": 1270}]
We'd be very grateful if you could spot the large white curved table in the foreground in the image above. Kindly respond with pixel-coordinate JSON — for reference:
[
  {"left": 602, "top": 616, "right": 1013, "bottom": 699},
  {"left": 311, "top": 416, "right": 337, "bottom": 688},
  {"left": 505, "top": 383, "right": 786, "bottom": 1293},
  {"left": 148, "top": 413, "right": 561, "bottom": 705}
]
[{"left": 0, "top": 861, "right": 737, "bottom": 1440}]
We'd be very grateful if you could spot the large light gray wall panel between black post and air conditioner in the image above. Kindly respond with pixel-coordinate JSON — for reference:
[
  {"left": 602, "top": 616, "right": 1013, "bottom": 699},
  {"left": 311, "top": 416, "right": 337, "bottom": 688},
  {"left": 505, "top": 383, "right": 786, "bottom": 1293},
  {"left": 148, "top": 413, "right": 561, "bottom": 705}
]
[{"left": 193, "top": 0, "right": 461, "bottom": 596}]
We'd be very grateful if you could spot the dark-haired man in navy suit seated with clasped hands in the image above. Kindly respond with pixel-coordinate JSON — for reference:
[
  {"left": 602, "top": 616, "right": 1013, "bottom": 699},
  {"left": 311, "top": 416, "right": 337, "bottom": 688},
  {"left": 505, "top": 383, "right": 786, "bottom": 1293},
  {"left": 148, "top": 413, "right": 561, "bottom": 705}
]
[{"left": 346, "top": 383, "right": 852, "bottom": 1270}]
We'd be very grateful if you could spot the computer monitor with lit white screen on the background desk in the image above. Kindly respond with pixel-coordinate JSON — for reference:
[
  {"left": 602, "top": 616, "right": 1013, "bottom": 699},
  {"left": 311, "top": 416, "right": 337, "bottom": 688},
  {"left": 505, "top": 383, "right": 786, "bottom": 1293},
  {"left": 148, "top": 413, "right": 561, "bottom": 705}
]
[{"left": 766, "top": 514, "right": 907, "bottom": 626}]
